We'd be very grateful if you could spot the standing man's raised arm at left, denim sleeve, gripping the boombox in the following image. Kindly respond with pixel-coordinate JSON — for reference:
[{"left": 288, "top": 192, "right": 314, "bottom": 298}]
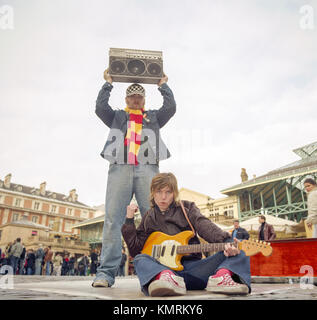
[{"left": 96, "top": 69, "right": 115, "bottom": 128}]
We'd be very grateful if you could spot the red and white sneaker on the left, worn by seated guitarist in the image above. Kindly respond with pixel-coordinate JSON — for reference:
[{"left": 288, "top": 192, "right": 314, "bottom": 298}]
[{"left": 149, "top": 270, "right": 186, "bottom": 297}]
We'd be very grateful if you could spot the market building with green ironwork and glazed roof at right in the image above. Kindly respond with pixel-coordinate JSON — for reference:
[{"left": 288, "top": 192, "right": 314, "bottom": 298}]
[{"left": 221, "top": 142, "right": 317, "bottom": 222}]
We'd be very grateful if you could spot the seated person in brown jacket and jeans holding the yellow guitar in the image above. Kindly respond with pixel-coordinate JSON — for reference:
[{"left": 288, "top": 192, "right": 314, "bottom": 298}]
[{"left": 121, "top": 173, "right": 251, "bottom": 297}]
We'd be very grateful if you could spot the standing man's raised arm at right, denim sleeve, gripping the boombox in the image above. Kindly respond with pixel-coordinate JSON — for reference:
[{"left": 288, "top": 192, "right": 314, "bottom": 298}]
[{"left": 157, "top": 74, "right": 176, "bottom": 128}]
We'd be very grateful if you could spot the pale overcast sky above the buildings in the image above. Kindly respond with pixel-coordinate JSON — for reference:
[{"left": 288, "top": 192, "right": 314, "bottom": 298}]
[{"left": 0, "top": 0, "right": 317, "bottom": 206}]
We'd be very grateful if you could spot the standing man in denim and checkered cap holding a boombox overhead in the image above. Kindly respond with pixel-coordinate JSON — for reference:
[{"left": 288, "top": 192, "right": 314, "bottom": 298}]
[{"left": 92, "top": 69, "right": 176, "bottom": 287}]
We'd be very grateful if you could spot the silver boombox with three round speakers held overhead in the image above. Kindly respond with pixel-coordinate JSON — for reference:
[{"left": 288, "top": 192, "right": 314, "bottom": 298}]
[{"left": 109, "top": 48, "right": 163, "bottom": 84}]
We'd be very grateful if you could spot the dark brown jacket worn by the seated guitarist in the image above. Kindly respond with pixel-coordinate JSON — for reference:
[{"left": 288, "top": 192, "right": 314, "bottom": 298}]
[{"left": 121, "top": 201, "right": 230, "bottom": 259}]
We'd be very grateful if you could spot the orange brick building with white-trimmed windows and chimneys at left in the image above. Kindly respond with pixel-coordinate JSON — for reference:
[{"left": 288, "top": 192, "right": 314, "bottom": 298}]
[{"left": 0, "top": 174, "right": 96, "bottom": 254}]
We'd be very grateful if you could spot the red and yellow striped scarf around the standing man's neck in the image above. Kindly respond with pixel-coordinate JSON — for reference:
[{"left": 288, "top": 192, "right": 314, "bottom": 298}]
[{"left": 124, "top": 107, "right": 144, "bottom": 165}]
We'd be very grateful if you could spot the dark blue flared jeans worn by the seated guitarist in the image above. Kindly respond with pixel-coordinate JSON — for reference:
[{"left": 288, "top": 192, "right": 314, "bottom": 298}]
[{"left": 133, "top": 251, "right": 251, "bottom": 295}]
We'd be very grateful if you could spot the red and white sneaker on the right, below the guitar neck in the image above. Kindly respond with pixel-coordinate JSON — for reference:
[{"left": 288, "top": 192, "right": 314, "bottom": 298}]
[{"left": 206, "top": 274, "right": 249, "bottom": 295}]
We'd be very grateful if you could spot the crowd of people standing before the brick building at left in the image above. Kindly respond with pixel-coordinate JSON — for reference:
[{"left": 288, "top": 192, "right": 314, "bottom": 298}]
[{"left": 0, "top": 238, "right": 121, "bottom": 276}]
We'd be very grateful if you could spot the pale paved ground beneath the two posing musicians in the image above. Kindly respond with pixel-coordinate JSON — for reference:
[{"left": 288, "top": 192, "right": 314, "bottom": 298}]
[{"left": 0, "top": 276, "right": 317, "bottom": 301}]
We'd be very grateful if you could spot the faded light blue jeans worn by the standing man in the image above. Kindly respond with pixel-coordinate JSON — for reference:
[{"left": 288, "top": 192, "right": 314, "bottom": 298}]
[{"left": 95, "top": 164, "right": 159, "bottom": 286}]
